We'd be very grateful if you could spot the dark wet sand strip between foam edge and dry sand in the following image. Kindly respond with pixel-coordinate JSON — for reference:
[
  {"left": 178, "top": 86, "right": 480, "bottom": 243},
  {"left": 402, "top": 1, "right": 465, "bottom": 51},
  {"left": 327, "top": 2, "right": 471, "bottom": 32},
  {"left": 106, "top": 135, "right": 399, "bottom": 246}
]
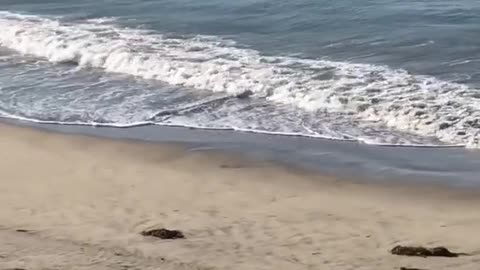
[{"left": 4, "top": 119, "right": 480, "bottom": 189}]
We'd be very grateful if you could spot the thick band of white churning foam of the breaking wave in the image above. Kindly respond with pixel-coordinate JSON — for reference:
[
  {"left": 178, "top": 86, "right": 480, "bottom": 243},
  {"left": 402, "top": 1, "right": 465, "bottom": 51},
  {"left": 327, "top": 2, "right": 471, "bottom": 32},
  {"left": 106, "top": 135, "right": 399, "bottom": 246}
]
[{"left": 0, "top": 12, "right": 480, "bottom": 147}]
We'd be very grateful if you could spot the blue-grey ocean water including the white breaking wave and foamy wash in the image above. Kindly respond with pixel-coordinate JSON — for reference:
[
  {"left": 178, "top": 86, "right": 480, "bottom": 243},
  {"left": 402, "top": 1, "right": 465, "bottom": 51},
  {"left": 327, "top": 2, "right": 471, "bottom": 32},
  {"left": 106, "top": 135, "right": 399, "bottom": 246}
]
[{"left": 0, "top": 0, "right": 480, "bottom": 147}]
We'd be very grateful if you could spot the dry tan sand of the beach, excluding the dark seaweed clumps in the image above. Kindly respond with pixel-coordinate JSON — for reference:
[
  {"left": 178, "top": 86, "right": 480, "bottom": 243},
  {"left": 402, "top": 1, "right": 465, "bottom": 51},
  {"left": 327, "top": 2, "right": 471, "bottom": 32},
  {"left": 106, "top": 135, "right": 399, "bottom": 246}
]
[{"left": 0, "top": 125, "right": 480, "bottom": 270}]
